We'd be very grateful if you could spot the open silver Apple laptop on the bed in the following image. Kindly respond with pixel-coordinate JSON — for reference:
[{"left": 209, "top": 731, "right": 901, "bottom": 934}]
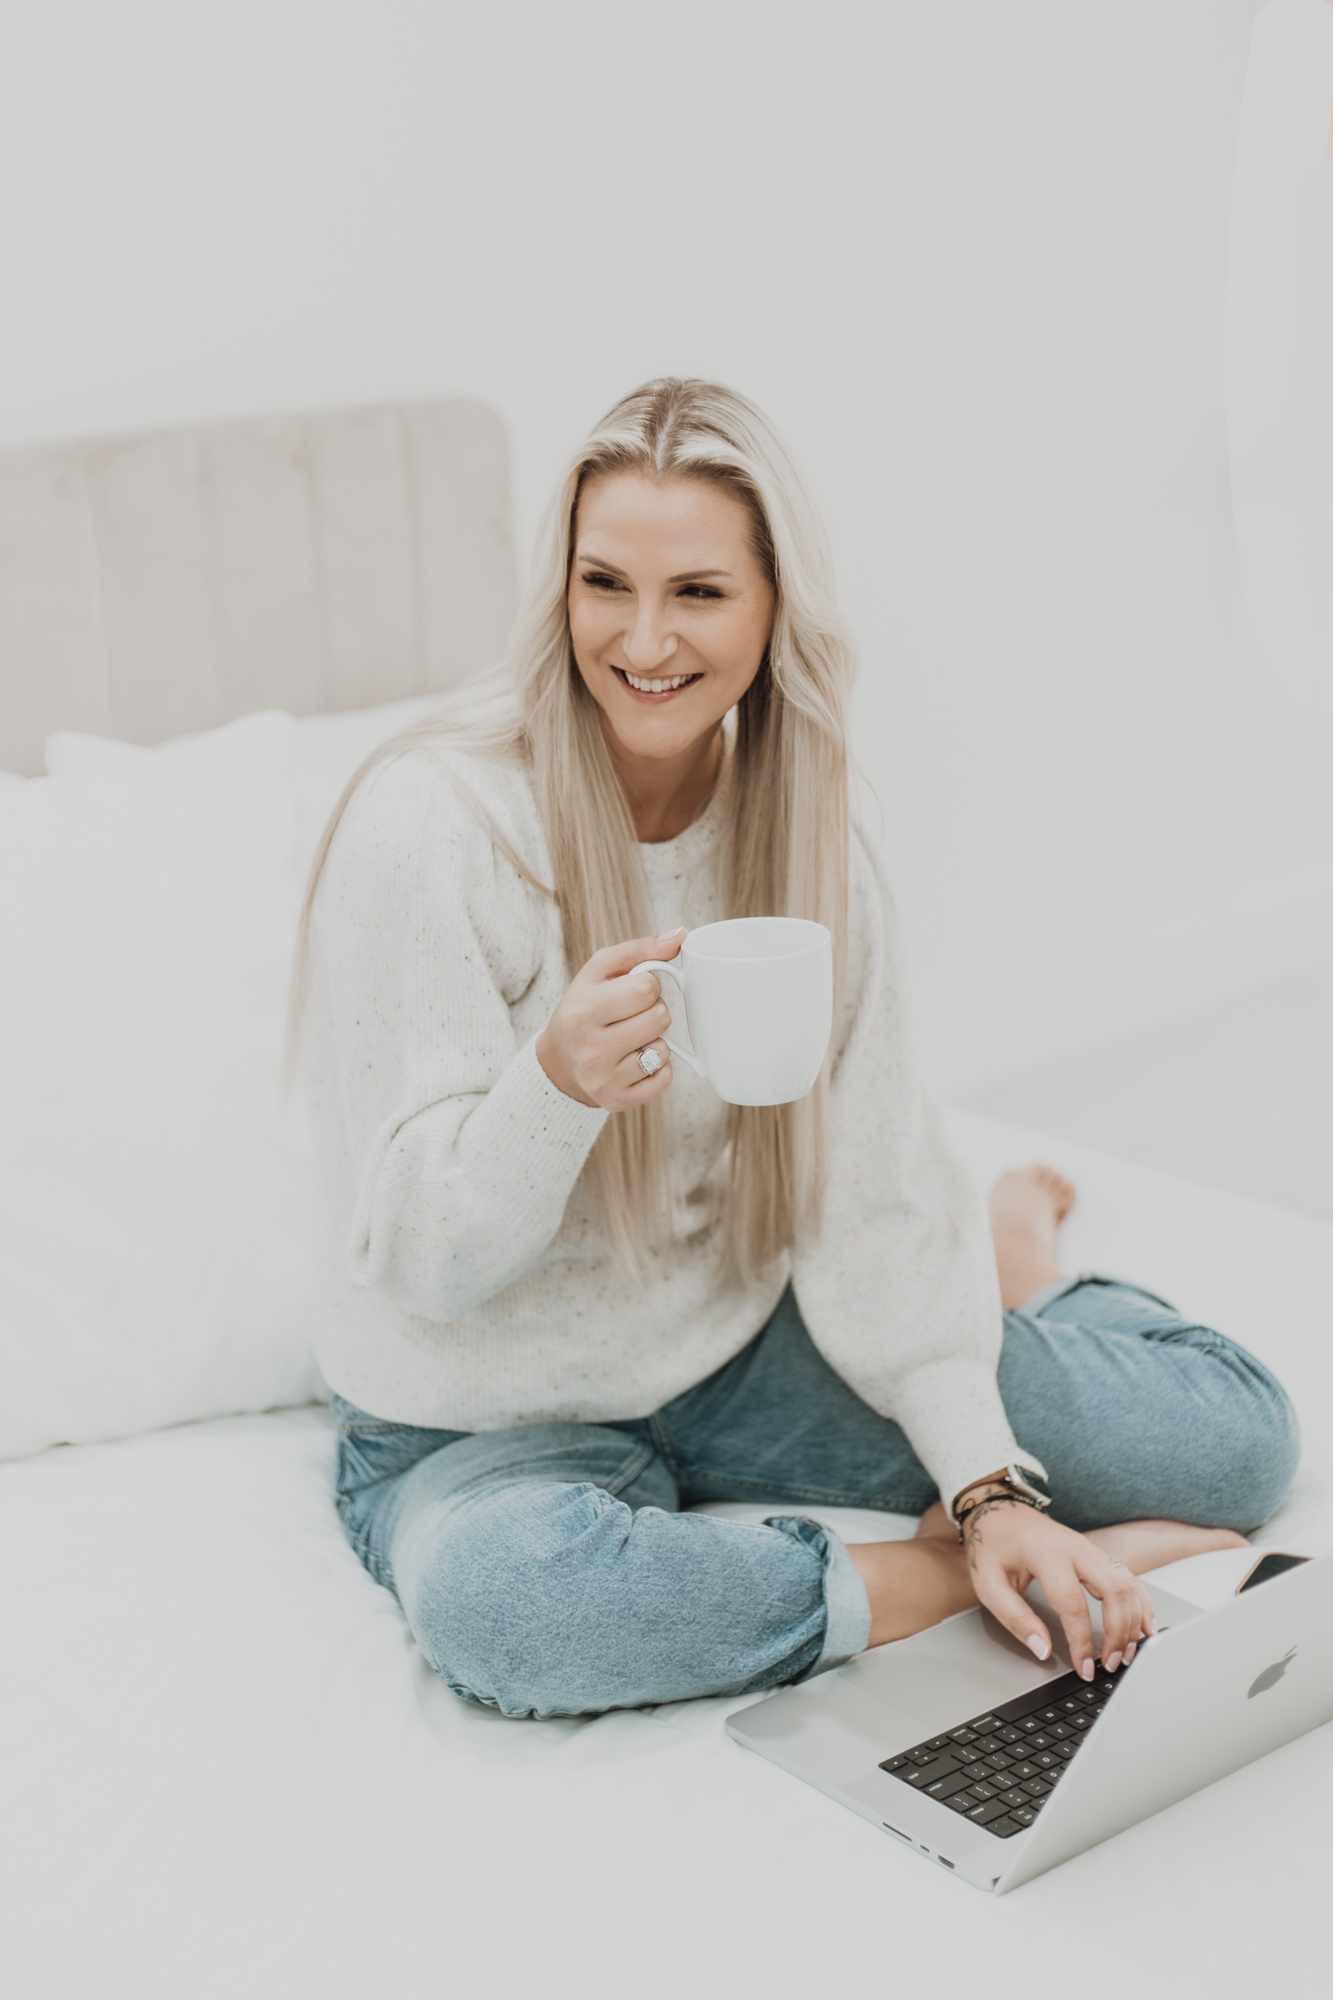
[{"left": 727, "top": 1554, "right": 1333, "bottom": 1896}]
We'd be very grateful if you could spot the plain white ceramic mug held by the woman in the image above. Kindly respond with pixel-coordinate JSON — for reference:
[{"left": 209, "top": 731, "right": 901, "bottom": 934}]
[{"left": 634, "top": 916, "right": 833, "bottom": 1104}]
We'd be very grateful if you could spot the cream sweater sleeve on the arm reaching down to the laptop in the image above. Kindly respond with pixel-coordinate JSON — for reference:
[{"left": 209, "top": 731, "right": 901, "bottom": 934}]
[{"left": 795, "top": 838, "right": 1041, "bottom": 1506}]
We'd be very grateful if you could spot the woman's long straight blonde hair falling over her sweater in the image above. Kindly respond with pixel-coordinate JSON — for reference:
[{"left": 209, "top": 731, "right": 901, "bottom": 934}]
[{"left": 292, "top": 378, "right": 855, "bottom": 1276}]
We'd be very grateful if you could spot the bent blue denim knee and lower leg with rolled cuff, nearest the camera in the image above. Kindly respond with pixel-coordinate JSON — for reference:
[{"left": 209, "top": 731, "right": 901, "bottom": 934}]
[{"left": 392, "top": 1480, "right": 836, "bottom": 1716}]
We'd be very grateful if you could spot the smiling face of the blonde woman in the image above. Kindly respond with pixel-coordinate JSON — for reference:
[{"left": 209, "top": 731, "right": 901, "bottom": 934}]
[{"left": 568, "top": 472, "right": 773, "bottom": 760}]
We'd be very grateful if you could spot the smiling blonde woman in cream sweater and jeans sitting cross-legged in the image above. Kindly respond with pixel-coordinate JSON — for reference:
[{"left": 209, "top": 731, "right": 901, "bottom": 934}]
[{"left": 306, "top": 380, "right": 1297, "bottom": 1716}]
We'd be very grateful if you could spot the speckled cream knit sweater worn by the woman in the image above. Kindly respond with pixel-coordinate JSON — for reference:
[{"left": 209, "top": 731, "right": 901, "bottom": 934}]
[{"left": 306, "top": 750, "right": 1017, "bottom": 1498}]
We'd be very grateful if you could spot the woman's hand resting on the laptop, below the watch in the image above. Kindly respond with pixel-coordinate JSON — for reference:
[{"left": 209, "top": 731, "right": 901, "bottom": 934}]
[{"left": 963, "top": 1496, "right": 1157, "bottom": 1680}]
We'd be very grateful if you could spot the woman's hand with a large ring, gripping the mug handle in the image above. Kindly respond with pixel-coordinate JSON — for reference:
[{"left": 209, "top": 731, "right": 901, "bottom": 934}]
[{"left": 536, "top": 930, "right": 685, "bottom": 1112}]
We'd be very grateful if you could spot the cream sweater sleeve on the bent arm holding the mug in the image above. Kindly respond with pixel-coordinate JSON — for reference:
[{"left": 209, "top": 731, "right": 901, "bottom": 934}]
[{"left": 314, "top": 754, "right": 606, "bottom": 1322}]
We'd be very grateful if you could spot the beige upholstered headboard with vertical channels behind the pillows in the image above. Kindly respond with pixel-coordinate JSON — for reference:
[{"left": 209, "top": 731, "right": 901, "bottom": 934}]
[{"left": 0, "top": 398, "right": 516, "bottom": 774}]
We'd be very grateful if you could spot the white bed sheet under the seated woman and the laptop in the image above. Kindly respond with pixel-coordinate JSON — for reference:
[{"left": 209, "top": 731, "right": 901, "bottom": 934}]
[{"left": 0, "top": 1120, "right": 1333, "bottom": 2000}]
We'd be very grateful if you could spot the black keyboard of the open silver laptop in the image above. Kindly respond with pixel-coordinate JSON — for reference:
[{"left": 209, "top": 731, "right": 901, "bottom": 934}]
[{"left": 879, "top": 1666, "right": 1125, "bottom": 1840}]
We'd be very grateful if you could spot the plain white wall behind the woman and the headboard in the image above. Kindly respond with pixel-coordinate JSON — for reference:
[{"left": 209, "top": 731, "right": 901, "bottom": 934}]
[{"left": 0, "top": 0, "right": 1333, "bottom": 1088}]
